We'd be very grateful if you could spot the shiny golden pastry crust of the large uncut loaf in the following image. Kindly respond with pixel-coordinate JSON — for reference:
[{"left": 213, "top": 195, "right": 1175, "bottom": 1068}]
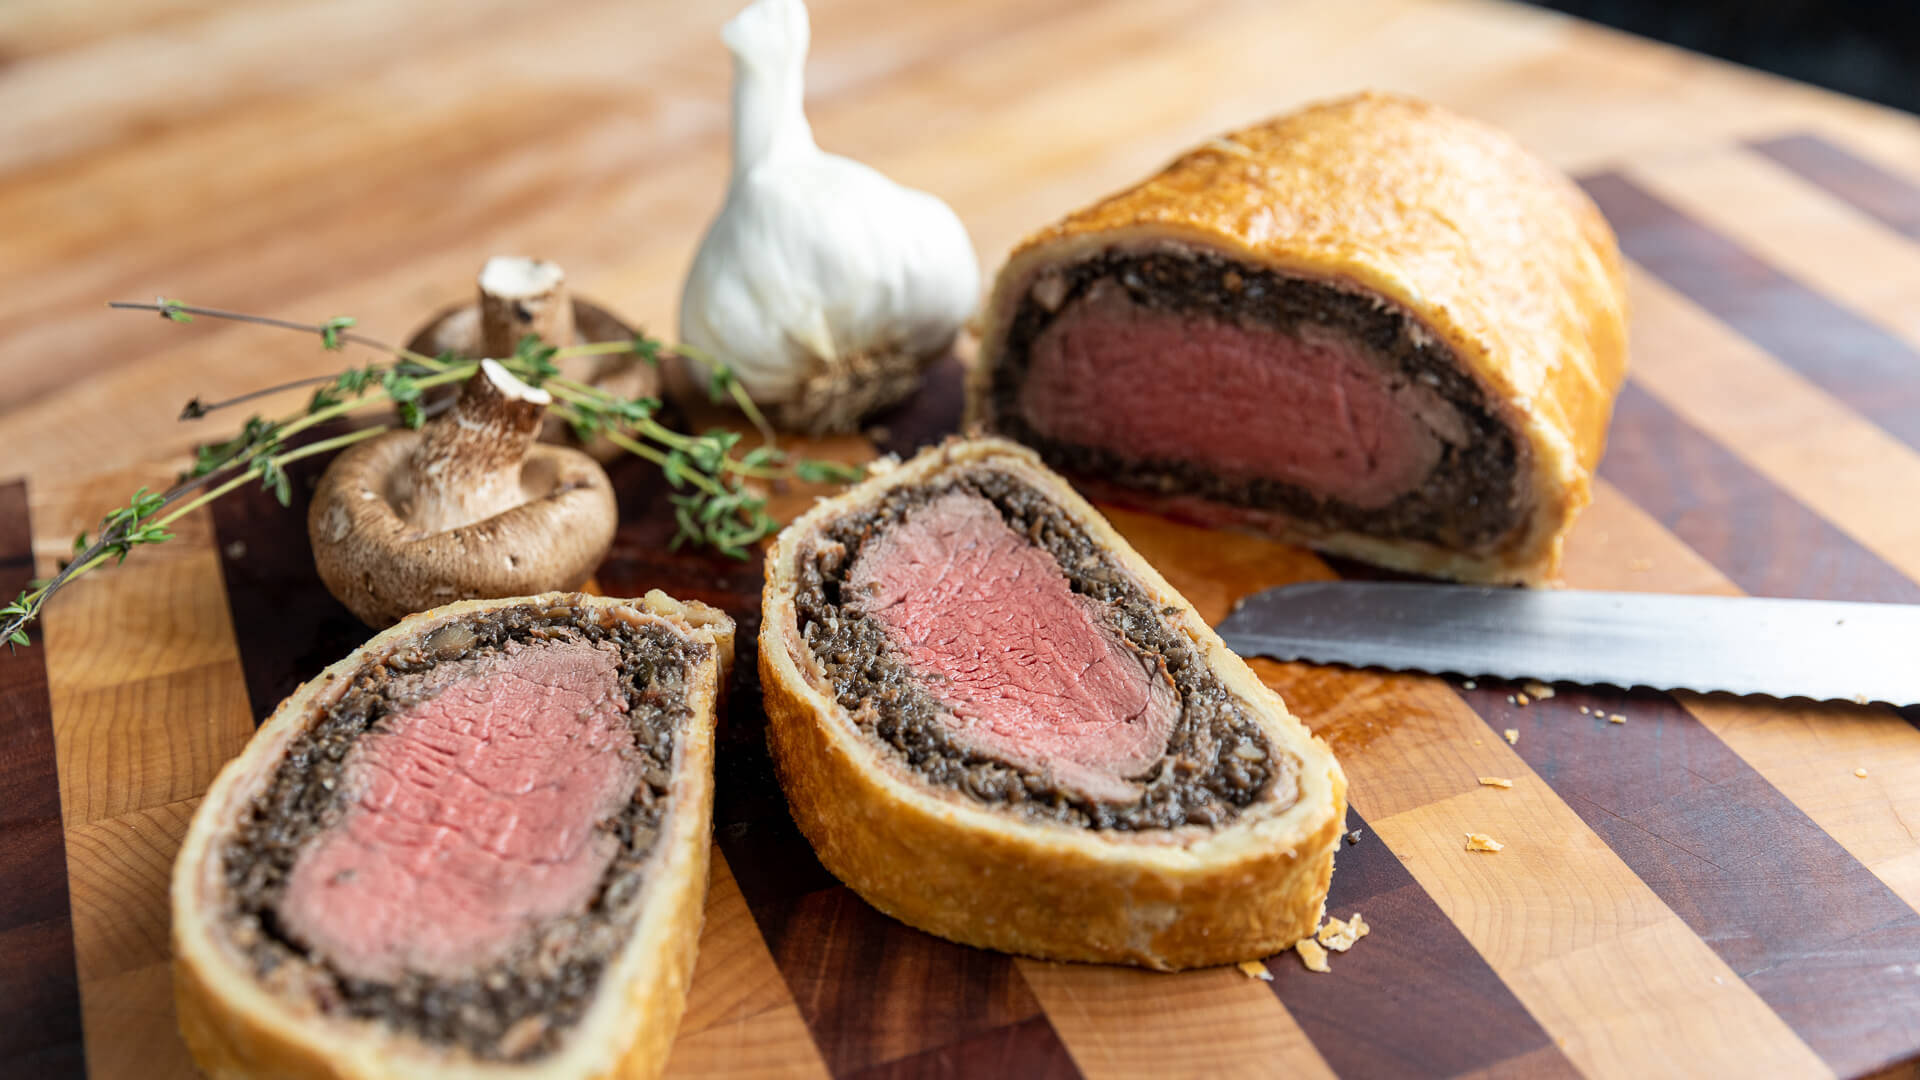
[{"left": 970, "top": 92, "right": 1626, "bottom": 584}]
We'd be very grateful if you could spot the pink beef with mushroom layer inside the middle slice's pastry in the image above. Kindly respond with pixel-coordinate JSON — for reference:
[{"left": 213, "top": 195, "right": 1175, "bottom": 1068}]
[{"left": 795, "top": 465, "right": 1298, "bottom": 830}]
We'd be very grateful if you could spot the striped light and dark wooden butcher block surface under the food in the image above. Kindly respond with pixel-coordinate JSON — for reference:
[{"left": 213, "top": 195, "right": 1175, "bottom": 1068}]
[{"left": 0, "top": 0, "right": 1920, "bottom": 1080}]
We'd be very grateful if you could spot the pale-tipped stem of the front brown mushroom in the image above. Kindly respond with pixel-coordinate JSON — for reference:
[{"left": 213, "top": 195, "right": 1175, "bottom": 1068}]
[{"left": 392, "top": 359, "right": 553, "bottom": 534}]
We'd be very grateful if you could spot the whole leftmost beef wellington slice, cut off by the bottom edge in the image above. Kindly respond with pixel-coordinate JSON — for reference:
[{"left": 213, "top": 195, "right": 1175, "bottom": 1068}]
[{"left": 173, "top": 592, "right": 733, "bottom": 1080}]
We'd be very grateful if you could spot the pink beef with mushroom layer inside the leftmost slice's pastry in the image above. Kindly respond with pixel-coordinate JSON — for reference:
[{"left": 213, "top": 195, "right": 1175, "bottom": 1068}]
[{"left": 223, "top": 605, "right": 707, "bottom": 1061}]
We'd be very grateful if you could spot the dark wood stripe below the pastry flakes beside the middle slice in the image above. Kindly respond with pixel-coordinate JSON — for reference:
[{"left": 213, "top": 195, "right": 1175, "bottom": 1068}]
[{"left": 1267, "top": 813, "right": 1578, "bottom": 1080}]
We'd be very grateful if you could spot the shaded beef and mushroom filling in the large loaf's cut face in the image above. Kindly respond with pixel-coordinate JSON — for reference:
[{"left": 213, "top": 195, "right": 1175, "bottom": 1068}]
[{"left": 993, "top": 252, "right": 1523, "bottom": 548}]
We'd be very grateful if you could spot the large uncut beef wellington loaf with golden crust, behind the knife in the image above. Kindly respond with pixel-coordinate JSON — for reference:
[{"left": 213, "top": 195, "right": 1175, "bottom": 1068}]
[{"left": 970, "top": 94, "right": 1626, "bottom": 584}]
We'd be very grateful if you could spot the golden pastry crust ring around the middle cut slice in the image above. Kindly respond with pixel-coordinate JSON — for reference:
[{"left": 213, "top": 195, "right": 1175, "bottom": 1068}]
[{"left": 760, "top": 438, "right": 1346, "bottom": 970}]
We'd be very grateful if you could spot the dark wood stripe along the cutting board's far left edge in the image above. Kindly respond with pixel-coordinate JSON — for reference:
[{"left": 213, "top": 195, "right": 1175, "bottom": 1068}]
[{"left": 0, "top": 480, "right": 86, "bottom": 1076}]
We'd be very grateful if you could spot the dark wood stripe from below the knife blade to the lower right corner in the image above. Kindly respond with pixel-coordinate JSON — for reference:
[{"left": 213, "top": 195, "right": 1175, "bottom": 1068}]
[{"left": 1461, "top": 680, "right": 1920, "bottom": 1076}]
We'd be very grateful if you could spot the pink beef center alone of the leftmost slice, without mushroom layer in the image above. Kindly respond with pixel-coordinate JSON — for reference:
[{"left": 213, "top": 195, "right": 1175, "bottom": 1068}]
[{"left": 278, "top": 642, "right": 639, "bottom": 982}]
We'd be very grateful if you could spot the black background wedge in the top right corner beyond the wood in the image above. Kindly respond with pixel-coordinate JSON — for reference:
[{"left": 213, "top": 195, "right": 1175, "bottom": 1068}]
[{"left": 1532, "top": 0, "right": 1920, "bottom": 111}]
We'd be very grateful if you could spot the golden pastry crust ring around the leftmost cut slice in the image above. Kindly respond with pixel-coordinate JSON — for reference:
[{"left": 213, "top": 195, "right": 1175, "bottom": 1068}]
[{"left": 173, "top": 592, "right": 733, "bottom": 1080}]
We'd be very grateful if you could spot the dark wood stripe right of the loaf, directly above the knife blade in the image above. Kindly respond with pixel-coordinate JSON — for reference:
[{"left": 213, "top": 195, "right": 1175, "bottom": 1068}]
[{"left": 1599, "top": 378, "right": 1920, "bottom": 603}]
